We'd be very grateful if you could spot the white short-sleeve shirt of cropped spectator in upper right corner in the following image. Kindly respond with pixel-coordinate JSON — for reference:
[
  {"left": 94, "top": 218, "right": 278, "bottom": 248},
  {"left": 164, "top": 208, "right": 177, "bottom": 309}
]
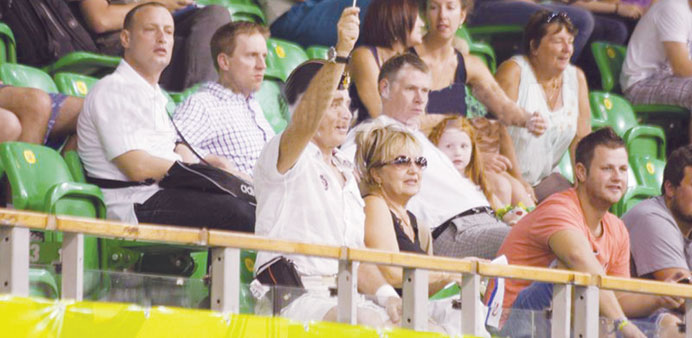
[{"left": 620, "top": 0, "right": 692, "bottom": 90}]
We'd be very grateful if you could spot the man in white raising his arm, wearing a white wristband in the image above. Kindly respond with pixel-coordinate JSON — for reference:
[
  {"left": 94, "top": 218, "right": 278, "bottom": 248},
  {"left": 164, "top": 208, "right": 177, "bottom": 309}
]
[{"left": 254, "top": 7, "right": 401, "bottom": 326}]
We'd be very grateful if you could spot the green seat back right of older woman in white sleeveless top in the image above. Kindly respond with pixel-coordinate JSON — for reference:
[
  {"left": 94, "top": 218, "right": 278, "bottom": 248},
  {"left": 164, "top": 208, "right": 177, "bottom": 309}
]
[{"left": 591, "top": 41, "right": 627, "bottom": 93}]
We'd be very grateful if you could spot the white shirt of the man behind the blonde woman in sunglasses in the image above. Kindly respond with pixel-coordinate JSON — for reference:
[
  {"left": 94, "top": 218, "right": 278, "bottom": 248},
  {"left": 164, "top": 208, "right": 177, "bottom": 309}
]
[{"left": 341, "top": 115, "right": 490, "bottom": 228}]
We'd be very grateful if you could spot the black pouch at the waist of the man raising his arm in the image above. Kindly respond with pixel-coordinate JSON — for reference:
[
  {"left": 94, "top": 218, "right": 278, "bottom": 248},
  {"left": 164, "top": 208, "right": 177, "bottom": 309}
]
[{"left": 255, "top": 256, "right": 306, "bottom": 315}]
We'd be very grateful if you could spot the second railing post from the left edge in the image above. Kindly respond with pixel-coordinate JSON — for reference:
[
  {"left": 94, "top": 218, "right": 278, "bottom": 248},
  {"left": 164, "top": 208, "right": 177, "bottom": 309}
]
[{"left": 61, "top": 232, "right": 84, "bottom": 301}]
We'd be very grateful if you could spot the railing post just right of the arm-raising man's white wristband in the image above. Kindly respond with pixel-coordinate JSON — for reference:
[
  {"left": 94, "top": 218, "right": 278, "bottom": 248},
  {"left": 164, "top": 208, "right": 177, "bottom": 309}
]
[{"left": 402, "top": 268, "right": 428, "bottom": 331}]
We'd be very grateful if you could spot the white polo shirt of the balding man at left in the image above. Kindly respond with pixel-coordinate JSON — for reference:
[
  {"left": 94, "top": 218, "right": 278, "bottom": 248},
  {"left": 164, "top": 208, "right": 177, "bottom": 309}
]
[{"left": 77, "top": 60, "right": 180, "bottom": 223}]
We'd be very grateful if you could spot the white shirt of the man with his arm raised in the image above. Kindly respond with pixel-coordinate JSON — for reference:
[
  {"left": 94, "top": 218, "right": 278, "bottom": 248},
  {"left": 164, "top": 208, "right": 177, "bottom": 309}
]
[{"left": 254, "top": 134, "right": 365, "bottom": 275}]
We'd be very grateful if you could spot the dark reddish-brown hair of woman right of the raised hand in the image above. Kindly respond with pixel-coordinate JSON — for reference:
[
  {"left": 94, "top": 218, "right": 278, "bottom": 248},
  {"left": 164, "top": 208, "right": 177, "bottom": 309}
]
[{"left": 362, "top": 0, "right": 418, "bottom": 48}]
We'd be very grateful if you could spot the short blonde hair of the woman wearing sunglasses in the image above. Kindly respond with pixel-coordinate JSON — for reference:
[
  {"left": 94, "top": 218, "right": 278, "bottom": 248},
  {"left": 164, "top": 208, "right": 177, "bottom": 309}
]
[{"left": 356, "top": 121, "right": 421, "bottom": 192}]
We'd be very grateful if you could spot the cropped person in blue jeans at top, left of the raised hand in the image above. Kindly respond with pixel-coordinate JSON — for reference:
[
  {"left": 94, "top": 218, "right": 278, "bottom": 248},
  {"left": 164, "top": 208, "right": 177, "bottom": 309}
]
[{"left": 258, "top": 0, "right": 371, "bottom": 48}]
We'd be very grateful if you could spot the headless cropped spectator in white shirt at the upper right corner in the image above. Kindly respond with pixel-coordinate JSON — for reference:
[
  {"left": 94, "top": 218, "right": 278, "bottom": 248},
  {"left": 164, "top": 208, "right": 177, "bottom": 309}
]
[{"left": 620, "top": 0, "right": 692, "bottom": 143}]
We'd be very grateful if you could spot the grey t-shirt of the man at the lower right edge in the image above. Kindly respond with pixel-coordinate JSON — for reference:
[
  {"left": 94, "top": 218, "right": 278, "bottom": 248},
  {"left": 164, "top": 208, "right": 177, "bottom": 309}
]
[{"left": 622, "top": 196, "right": 692, "bottom": 278}]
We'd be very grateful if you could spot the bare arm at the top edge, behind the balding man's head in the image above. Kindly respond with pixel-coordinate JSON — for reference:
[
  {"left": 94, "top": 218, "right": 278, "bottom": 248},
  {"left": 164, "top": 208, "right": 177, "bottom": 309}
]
[{"left": 80, "top": 0, "right": 193, "bottom": 34}]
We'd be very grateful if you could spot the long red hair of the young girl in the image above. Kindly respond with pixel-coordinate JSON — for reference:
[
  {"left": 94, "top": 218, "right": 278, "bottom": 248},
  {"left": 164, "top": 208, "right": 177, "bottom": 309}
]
[{"left": 427, "top": 115, "right": 493, "bottom": 201}]
